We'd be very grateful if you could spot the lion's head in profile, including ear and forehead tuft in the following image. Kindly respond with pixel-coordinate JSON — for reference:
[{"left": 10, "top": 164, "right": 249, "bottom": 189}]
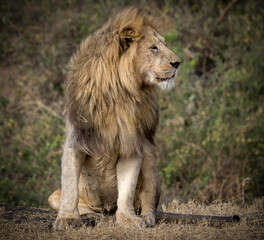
[{"left": 117, "top": 8, "right": 180, "bottom": 89}]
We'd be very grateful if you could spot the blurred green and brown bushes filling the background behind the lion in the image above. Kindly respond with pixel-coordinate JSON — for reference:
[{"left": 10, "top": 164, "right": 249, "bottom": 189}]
[{"left": 0, "top": 0, "right": 264, "bottom": 206}]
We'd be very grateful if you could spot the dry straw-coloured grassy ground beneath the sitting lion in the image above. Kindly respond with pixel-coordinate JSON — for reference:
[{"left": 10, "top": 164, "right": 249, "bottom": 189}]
[{"left": 0, "top": 199, "right": 264, "bottom": 239}]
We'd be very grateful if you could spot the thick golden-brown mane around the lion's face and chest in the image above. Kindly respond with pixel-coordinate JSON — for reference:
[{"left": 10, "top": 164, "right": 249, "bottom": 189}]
[{"left": 65, "top": 7, "right": 161, "bottom": 156}]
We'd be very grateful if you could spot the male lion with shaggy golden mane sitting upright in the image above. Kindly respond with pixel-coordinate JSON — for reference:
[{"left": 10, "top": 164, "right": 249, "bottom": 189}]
[{"left": 49, "top": 7, "right": 180, "bottom": 229}]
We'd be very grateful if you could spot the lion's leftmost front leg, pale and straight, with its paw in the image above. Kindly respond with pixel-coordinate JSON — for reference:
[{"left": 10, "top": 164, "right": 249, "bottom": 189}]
[{"left": 53, "top": 131, "right": 83, "bottom": 230}]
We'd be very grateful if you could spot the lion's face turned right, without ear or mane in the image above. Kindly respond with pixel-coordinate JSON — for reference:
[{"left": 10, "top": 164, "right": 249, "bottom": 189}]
[{"left": 135, "top": 28, "right": 180, "bottom": 89}]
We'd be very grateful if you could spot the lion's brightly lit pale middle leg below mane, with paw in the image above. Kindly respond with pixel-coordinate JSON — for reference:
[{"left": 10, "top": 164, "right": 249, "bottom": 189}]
[{"left": 116, "top": 156, "right": 145, "bottom": 227}]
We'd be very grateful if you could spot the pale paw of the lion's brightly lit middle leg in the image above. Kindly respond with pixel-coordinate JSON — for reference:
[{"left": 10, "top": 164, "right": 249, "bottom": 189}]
[{"left": 116, "top": 210, "right": 147, "bottom": 228}]
